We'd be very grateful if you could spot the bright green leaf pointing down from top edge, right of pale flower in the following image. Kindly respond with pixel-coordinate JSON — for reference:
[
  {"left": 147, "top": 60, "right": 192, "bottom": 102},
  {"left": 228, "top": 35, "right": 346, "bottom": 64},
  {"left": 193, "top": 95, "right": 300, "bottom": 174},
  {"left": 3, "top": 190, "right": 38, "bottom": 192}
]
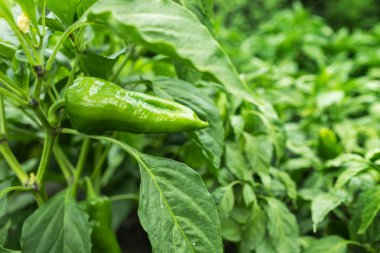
[{"left": 46, "top": 0, "right": 79, "bottom": 26}]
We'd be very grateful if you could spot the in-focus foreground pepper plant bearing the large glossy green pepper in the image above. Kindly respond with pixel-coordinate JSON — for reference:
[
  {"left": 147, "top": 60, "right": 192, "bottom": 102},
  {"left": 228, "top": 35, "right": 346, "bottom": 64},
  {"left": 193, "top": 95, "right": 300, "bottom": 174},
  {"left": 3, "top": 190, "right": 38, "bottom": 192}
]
[{"left": 0, "top": 0, "right": 242, "bottom": 252}]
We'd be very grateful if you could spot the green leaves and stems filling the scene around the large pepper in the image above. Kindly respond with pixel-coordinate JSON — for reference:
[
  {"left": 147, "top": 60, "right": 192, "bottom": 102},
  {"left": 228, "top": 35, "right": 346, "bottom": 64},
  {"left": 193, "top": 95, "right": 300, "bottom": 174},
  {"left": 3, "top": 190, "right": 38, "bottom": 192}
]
[{"left": 0, "top": 0, "right": 380, "bottom": 253}]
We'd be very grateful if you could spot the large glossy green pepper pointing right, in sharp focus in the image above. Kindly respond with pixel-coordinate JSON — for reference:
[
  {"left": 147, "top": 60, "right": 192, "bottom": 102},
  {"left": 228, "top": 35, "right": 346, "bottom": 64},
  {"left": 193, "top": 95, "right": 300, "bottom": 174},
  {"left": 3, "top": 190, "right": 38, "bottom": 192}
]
[{"left": 65, "top": 77, "right": 208, "bottom": 133}]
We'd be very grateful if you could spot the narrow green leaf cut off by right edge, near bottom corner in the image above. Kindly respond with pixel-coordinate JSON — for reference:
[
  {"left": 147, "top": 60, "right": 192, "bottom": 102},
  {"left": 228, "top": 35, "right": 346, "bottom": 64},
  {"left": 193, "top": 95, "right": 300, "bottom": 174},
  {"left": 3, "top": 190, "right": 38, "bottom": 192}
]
[{"left": 358, "top": 187, "right": 380, "bottom": 234}]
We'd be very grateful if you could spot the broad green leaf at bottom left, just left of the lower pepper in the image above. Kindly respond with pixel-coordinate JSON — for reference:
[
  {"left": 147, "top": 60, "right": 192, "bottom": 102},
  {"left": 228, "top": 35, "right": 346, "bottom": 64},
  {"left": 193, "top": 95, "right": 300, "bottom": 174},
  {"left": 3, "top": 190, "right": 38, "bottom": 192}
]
[{"left": 21, "top": 190, "right": 91, "bottom": 253}]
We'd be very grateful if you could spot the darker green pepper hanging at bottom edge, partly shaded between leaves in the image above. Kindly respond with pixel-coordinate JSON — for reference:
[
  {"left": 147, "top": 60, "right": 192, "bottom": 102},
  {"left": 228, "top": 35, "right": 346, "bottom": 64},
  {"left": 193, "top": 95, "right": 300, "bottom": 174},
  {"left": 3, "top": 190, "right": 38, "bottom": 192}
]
[{"left": 83, "top": 196, "right": 121, "bottom": 253}]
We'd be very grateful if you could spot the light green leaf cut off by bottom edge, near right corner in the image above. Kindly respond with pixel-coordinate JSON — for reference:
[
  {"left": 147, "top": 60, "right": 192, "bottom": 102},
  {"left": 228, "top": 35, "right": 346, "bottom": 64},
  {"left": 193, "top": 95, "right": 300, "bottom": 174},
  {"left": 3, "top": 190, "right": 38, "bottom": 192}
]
[{"left": 305, "top": 235, "right": 348, "bottom": 253}]
